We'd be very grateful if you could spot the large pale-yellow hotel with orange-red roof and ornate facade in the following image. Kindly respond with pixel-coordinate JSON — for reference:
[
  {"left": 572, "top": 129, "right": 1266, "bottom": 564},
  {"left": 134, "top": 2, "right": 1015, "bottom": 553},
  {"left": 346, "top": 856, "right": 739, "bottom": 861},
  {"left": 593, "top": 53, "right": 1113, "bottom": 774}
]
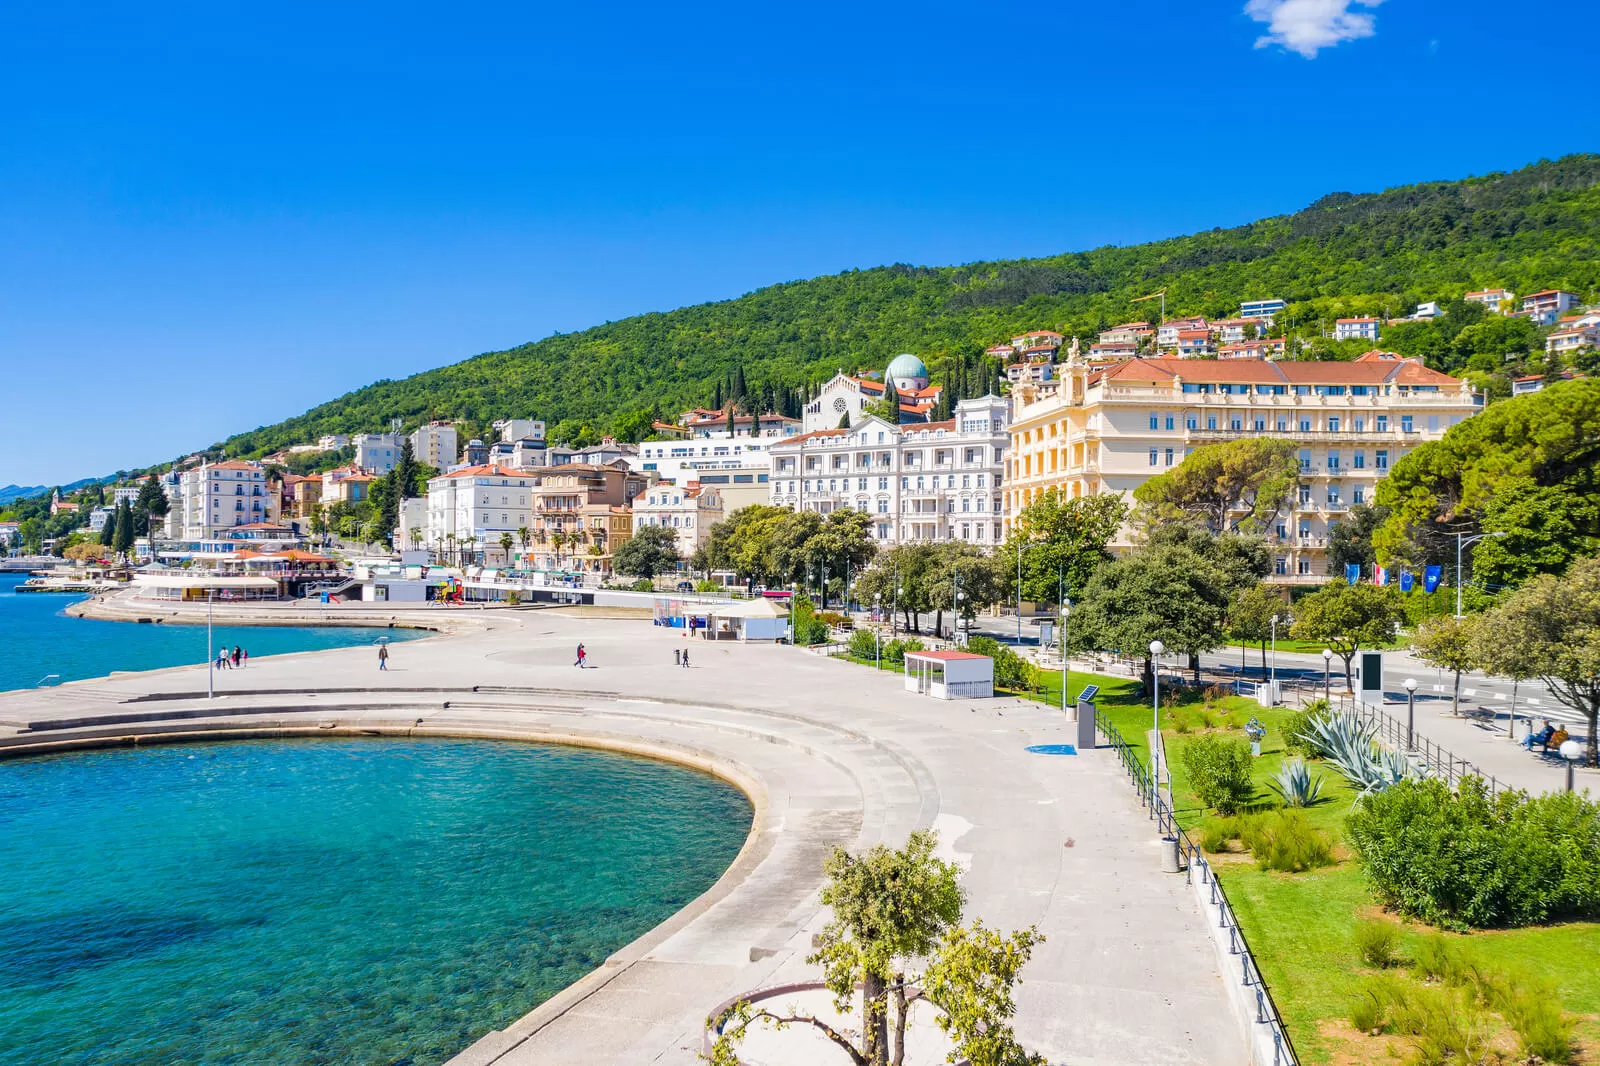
[{"left": 1003, "top": 352, "right": 1482, "bottom": 583}]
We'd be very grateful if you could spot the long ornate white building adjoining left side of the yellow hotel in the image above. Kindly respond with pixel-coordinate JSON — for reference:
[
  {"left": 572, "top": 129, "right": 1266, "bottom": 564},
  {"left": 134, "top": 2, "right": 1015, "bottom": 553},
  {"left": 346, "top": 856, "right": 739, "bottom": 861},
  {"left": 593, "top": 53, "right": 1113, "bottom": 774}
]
[{"left": 770, "top": 395, "right": 1010, "bottom": 544}]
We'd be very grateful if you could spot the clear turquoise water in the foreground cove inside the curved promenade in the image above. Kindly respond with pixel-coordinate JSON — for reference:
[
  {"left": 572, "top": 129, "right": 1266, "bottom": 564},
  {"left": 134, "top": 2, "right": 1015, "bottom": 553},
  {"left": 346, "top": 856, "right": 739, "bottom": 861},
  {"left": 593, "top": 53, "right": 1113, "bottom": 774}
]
[{"left": 0, "top": 739, "right": 750, "bottom": 1066}]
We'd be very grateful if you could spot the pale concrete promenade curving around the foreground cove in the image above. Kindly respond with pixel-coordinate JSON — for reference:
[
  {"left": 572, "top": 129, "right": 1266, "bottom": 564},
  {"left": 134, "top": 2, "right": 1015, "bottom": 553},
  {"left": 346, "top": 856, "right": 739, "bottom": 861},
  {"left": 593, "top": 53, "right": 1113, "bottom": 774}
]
[{"left": 0, "top": 608, "right": 1248, "bottom": 1066}]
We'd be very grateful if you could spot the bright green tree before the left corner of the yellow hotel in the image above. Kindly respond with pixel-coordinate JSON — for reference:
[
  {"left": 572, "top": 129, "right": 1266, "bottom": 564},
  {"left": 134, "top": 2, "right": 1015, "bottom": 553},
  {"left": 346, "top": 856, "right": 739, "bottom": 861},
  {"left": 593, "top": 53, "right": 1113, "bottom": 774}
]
[{"left": 995, "top": 488, "right": 1128, "bottom": 603}]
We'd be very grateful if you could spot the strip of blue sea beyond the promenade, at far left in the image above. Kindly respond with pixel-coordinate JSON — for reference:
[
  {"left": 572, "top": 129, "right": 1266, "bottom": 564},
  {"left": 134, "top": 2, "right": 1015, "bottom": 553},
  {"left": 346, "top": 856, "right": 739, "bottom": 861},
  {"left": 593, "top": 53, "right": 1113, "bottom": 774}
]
[{"left": 0, "top": 573, "right": 426, "bottom": 690}]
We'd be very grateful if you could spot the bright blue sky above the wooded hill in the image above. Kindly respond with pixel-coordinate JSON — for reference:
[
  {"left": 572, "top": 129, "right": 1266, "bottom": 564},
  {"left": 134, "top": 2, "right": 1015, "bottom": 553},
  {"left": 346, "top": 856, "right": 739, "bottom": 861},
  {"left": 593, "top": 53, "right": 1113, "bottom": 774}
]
[{"left": 0, "top": 0, "right": 1597, "bottom": 485}]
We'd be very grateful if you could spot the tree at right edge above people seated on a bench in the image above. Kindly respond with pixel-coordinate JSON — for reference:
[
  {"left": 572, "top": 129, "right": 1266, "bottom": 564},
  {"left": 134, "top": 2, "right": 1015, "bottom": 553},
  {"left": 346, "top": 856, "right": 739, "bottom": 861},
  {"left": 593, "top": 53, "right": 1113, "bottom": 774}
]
[{"left": 1482, "top": 555, "right": 1600, "bottom": 767}]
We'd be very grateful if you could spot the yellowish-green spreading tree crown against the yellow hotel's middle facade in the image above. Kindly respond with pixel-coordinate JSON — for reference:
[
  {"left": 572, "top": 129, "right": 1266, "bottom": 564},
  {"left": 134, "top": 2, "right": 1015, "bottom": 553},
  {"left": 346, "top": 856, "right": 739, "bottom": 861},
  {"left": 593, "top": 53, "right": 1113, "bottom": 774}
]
[{"left": 1133, "top": 437, "right": 1299, "bottom": 533}]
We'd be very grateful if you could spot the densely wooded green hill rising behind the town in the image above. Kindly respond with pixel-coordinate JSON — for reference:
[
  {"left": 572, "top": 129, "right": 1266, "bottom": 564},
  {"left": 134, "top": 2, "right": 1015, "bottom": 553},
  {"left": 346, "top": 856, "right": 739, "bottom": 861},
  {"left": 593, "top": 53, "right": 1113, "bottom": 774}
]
[{"left": 226, "top": 155, "right": 1600, "bottom": 455}]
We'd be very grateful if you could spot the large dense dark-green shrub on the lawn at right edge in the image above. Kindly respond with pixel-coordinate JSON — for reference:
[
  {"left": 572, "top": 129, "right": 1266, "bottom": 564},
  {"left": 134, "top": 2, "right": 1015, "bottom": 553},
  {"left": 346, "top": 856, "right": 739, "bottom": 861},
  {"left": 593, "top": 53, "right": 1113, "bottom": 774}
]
[{"left": 1347, "top": 778, "right": 1600, "bottom": 928}]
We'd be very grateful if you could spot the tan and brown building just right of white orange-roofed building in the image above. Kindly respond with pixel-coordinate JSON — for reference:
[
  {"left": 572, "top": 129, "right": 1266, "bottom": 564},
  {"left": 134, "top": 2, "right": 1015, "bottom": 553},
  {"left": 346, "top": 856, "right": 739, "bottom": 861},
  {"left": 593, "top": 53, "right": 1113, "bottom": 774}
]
[{"left": 530, "top": 464, "right": 651, "bottom": 578}]
